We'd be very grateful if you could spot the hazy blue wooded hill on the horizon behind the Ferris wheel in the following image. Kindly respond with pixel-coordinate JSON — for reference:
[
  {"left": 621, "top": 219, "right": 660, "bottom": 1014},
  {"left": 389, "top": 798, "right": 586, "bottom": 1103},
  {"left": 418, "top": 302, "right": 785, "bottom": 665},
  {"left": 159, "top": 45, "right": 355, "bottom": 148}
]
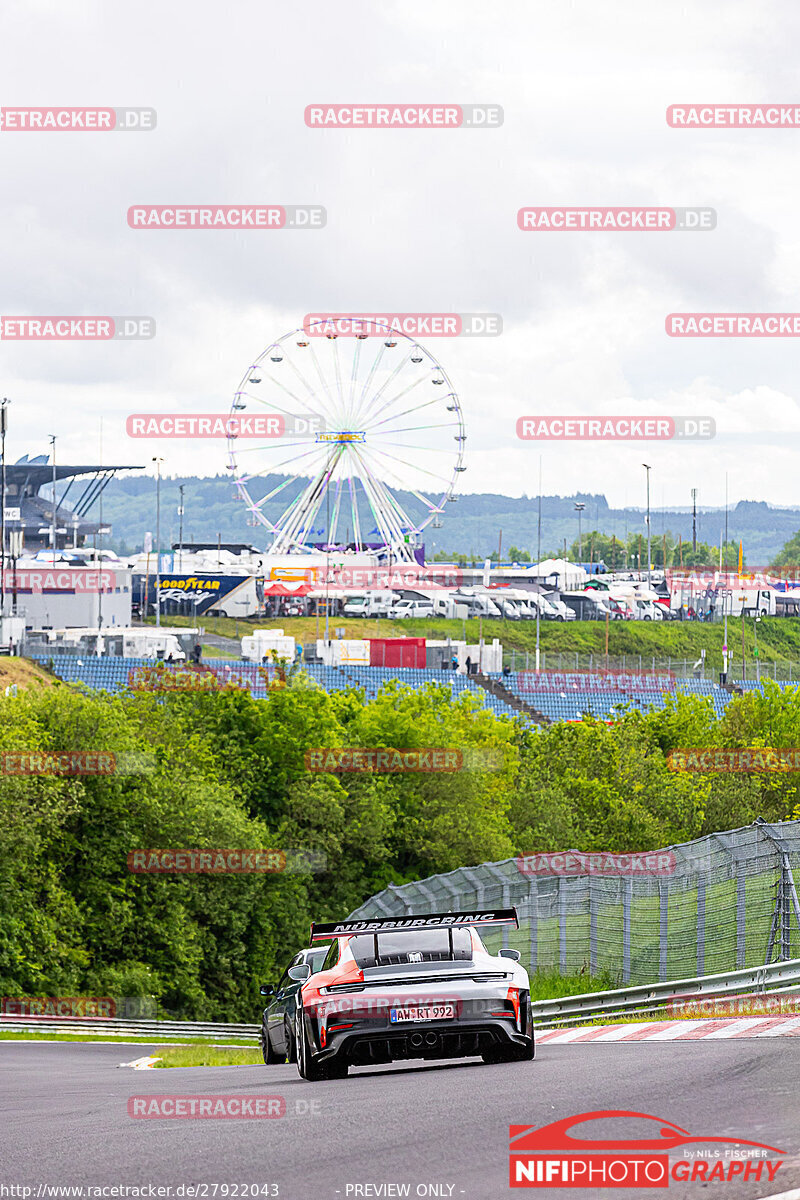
[{"left": 92, "top": 475, "right": 800, "bottom": 565}]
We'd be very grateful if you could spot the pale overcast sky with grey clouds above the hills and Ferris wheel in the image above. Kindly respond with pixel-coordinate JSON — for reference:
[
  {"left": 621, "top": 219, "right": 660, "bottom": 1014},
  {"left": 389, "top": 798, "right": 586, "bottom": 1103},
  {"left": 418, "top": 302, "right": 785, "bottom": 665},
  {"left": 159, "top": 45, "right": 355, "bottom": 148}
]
[{"left": 0, "top": 0, "right": 800, "bottom": 520}]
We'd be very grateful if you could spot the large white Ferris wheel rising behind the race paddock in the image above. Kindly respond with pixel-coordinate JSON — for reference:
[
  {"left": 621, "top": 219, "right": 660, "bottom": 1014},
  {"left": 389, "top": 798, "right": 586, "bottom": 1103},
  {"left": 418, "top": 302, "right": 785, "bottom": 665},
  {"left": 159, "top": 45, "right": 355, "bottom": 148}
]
[{"left": 228, "top": 318, "right": 467, "bottom": 560}]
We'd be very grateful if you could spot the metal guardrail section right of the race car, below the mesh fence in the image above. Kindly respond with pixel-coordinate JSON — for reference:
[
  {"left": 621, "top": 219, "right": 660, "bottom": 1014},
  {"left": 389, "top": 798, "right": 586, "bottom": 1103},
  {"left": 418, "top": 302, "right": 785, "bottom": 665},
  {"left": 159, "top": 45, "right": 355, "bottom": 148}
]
[{"left": 531, "top": 959, "right": 800, "bottom": 1027}]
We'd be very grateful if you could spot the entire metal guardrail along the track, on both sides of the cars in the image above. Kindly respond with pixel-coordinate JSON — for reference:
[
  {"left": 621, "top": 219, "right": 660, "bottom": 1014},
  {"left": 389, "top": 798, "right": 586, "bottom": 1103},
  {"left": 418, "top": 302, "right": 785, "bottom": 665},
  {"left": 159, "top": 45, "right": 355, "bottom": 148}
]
[{"left": 6, "top": 959, "right": 800, "bottom": 1040}]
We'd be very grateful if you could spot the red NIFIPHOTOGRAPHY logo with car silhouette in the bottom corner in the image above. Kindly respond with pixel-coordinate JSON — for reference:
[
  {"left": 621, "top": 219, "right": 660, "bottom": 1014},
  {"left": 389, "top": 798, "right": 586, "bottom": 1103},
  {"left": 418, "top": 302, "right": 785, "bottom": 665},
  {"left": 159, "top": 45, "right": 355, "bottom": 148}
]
[{"left": 509, "top": 1109, "right": 784, "bottom": 1188}]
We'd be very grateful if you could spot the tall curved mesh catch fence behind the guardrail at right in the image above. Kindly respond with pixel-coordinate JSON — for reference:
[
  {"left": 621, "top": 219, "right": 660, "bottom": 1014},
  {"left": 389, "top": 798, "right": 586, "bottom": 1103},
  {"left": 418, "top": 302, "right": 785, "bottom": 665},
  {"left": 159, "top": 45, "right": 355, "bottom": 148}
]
[{"left": 350, "top": 818, "right": 800, "bottom": 984}]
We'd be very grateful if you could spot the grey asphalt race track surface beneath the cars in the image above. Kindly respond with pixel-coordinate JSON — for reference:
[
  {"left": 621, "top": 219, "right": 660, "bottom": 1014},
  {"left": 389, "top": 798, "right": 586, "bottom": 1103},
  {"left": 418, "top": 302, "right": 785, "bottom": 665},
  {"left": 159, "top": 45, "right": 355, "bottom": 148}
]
[{"left": 0, "top": 1038, "right": 800, "bottom": 1200}]
